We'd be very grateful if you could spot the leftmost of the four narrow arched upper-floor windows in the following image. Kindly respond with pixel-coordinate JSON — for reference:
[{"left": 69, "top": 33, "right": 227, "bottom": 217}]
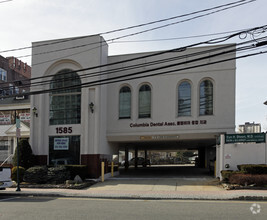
[{"left": 119, "top": 86, "right": 131, "bottom": 119}]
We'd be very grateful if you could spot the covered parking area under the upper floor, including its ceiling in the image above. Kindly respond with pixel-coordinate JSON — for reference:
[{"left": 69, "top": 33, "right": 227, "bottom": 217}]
[{"left": 113, "top": 133, "right": 218, "bottom": 177}]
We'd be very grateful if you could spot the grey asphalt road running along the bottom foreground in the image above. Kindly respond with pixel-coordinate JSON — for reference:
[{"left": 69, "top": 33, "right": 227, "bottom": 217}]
[{"left": 0, "top": 196, "right": 267, "bottom": 220}]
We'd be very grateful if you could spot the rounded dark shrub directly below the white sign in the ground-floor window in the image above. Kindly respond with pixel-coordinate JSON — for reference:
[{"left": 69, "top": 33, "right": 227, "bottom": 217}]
[{"left": 47, "top": 166, "right": 70, "bottom": 184}]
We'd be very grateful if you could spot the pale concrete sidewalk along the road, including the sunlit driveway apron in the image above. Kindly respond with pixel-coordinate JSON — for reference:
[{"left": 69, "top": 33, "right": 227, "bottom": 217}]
[{"left": 0, "top": 177, "right": 267, "bottom": 201}]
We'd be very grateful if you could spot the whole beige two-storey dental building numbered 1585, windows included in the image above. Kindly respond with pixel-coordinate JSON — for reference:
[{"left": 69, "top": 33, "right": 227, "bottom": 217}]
[{"left": 30, "top": 35, "right": 236, "bottom": 177}]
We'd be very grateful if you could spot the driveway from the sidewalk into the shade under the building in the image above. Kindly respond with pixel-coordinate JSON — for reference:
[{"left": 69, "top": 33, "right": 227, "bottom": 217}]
[{"left": 89, "top": 165, "right": 223, "bottom": 192}]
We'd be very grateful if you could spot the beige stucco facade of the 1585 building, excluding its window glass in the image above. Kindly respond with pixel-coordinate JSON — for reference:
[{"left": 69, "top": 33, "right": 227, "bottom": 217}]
[{"left": 30, "top": 35, "right": 236, "bottom": 176}]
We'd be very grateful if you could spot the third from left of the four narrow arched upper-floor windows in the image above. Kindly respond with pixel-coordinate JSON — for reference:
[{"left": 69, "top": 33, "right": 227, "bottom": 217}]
[{"left": 178, "top": 81, "right": 191, "bottom": 116}]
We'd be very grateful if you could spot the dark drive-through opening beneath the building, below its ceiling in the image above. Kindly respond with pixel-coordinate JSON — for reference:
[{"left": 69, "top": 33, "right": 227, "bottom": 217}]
[{"left": 119, "top": 140, "right": 216, "bottom": 177}]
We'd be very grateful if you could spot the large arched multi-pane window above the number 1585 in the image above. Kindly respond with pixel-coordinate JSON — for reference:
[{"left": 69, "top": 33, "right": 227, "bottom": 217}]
[{"left": 50, "top": 69, "right": 81, "bottom": 125}]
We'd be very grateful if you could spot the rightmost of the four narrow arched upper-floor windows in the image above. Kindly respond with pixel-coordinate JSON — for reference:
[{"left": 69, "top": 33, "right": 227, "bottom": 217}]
[{"left": 199, "top": 80, "right": 213, "bottom": 115}]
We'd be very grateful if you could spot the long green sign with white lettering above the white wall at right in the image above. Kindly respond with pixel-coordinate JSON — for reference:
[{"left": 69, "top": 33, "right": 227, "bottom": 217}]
[{"left": 225, "top": 133, "right": 266, "bottom": 144}]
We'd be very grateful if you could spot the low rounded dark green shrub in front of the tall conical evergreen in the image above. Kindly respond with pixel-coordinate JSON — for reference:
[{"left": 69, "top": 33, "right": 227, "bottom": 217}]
[{"left": 23, "top": 166, "right": 48, "bottom": 183}]
